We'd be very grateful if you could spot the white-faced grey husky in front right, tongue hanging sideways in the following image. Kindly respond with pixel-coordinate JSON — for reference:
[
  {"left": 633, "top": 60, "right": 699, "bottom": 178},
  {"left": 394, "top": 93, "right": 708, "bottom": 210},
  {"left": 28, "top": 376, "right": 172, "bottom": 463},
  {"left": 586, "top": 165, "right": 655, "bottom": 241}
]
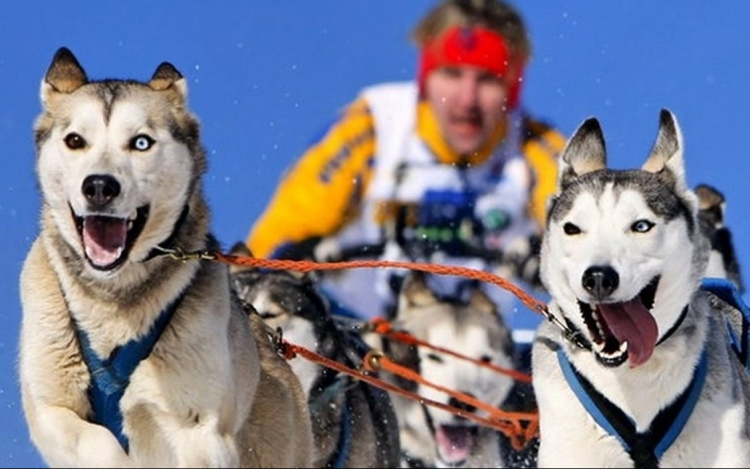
[{"left": 532, "top": 109, "right": 750, "bottom": 467}]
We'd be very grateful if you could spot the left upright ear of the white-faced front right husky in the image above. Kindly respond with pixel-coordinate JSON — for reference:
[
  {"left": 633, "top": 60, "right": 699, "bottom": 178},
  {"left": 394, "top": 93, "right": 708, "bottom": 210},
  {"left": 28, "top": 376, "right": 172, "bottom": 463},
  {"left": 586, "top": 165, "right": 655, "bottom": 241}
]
[{"left": 557, "top": 117, "right": 607, "bottom": 189}]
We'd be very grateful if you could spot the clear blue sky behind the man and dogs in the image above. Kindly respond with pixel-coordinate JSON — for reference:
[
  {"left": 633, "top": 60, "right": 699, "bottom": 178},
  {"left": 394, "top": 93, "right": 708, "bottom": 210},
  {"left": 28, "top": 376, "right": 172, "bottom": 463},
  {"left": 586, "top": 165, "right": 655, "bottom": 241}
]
[{"left": 0, "top": 0, "right": 750, "bottom": 467}]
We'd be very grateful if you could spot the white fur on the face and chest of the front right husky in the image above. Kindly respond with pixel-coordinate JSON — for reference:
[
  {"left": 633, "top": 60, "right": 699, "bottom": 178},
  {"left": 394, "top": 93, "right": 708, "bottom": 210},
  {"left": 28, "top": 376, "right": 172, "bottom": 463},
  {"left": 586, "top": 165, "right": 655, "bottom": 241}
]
[{"left": 532, "top": 111, "right": 750, "bottom": 467}]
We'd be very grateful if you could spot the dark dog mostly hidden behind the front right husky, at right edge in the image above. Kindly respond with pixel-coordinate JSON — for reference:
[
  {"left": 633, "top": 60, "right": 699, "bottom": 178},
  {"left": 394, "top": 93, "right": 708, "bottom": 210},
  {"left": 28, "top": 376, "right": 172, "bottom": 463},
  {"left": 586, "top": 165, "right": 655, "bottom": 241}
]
[{"left": 695, "top": 184, "right": 745, "bottom": 293}]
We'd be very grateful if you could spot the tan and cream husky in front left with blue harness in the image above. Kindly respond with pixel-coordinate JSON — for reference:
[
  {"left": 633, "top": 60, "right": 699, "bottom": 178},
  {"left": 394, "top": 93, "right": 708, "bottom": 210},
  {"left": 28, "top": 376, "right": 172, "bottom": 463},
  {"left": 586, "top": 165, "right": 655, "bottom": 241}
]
[{"left": 19, "top": 48, "right": 313, "bottom": 467}]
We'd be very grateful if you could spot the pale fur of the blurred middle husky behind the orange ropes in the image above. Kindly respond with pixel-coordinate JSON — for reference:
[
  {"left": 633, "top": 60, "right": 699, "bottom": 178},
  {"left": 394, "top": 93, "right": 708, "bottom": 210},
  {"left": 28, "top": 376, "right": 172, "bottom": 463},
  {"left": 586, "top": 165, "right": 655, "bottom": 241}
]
[{"left": 382, "top": 276, "right": 516, "bottom": 467}]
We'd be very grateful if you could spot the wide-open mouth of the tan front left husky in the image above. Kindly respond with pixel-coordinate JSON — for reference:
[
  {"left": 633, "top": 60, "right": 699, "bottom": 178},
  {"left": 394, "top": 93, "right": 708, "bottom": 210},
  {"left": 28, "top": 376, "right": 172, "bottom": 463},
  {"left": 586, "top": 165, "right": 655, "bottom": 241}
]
[{"left": 71, "top": 205, "right": 149, "bottom": 271}]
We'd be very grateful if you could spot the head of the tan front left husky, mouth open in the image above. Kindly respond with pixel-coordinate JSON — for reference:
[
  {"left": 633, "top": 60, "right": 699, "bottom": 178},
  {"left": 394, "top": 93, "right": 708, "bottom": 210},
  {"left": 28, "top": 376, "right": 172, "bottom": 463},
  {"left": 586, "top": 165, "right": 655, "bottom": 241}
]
[{"left": 34, "top": 47, "right": 208, "bottom": 281}]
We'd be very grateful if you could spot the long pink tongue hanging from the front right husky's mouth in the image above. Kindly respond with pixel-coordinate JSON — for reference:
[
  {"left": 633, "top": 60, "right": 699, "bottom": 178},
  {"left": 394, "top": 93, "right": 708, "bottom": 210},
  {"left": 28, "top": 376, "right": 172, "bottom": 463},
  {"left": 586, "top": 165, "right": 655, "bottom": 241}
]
[{"left": 598, "top": 299, "right": 659, "bottom": 366}]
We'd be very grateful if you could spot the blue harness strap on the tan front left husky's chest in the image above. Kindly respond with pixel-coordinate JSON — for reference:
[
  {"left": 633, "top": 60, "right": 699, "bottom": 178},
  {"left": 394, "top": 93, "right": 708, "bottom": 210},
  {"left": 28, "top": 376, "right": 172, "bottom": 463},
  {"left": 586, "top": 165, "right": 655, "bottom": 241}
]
[{"left": 76, "top": 295, "right": 183, "bottom": 452}]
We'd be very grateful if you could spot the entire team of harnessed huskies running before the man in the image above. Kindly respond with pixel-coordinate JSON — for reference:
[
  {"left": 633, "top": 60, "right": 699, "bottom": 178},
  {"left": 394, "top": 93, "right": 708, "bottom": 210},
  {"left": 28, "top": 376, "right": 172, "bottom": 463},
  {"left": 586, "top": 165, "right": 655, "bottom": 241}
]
[{"left": 19, "top": 48, "right": 750, "bottom": 467}]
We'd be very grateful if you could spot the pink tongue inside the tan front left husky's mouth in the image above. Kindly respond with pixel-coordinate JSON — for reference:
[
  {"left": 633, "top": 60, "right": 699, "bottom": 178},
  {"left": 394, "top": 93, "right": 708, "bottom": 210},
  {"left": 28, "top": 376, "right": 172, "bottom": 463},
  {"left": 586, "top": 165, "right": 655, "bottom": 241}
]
[{"left": 83, "top": 216, "right": 128, "bottom": 266}]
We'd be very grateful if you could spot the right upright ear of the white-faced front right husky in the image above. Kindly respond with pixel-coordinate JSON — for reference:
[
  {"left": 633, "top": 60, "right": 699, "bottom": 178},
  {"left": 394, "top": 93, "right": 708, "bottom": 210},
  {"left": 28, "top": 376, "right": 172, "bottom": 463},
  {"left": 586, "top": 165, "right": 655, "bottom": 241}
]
[{"left": 641, "top": 109, "right": 687, "bottom": 192}]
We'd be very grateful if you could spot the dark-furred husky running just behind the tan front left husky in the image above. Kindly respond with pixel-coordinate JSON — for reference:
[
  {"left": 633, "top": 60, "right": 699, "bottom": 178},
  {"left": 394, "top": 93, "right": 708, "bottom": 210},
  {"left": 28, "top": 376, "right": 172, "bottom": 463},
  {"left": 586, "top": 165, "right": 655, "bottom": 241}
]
[{"left": 230, "top": 242, "right": 401, "bottom": 468}]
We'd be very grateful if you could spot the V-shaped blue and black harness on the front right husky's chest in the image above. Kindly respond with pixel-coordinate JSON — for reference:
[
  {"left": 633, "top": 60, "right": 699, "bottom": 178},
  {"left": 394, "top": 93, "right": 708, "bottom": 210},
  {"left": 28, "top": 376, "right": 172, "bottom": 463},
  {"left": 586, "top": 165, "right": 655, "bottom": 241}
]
[{"left": 557, "top": 347, "right": 708, "bottom": 468}]
